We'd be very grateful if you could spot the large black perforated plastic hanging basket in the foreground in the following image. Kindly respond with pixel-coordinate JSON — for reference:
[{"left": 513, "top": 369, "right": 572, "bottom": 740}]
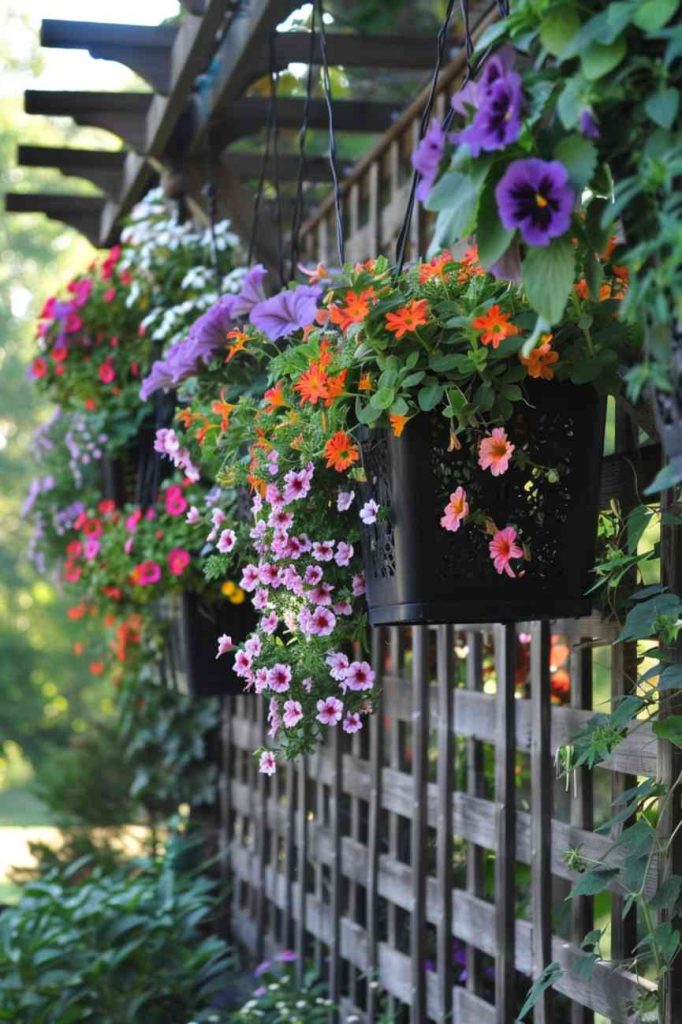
[{"left": 360, "top": 381, "right": 605, "bottom": 626}]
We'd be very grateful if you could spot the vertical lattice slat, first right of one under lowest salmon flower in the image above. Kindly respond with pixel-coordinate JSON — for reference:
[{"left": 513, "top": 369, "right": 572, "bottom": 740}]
[{"left": 530, "top": 621, "right": 554, "bottom": 1024}]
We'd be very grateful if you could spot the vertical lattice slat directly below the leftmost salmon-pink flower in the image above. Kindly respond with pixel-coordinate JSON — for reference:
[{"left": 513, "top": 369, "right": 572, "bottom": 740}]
[{"left": 436, "top": 626, "right": 455, "bottom": 1021}]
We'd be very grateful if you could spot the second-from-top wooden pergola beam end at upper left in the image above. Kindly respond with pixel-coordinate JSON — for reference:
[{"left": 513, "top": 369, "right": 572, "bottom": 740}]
[{"left": 24, "top": 89, "right": 152, "bottom": 148}]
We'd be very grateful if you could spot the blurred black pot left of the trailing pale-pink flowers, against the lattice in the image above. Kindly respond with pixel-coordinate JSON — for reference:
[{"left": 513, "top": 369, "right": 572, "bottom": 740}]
[{"left": 170, "top": 591, "right": 257, "bottom": 697}]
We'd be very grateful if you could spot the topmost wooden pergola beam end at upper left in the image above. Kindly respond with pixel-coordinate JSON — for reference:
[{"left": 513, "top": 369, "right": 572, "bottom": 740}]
[{"left": 40, "top": 18, "right": 177, "bottom": 94}]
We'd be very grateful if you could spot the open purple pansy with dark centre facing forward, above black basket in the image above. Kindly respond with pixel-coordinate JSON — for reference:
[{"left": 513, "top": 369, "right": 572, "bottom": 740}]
[{"left": 495, "top": 157, "right": 576, "bottom": 247}]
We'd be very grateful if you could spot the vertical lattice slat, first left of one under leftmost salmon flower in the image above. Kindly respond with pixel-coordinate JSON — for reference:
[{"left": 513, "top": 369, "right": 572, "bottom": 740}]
[{"left": 410, "top": 626, "right": 429, "bottom": 1021}]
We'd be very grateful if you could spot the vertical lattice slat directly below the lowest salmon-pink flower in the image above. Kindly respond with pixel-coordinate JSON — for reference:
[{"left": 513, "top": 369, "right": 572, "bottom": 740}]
[{"left": 491, "top": 626, "right": 516, "bottom": 1024}]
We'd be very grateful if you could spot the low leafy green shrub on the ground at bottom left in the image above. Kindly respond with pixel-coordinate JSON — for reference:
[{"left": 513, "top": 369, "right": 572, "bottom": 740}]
[{"left": 0, "top": 861, "right": 230, "bottom": 1024}]
